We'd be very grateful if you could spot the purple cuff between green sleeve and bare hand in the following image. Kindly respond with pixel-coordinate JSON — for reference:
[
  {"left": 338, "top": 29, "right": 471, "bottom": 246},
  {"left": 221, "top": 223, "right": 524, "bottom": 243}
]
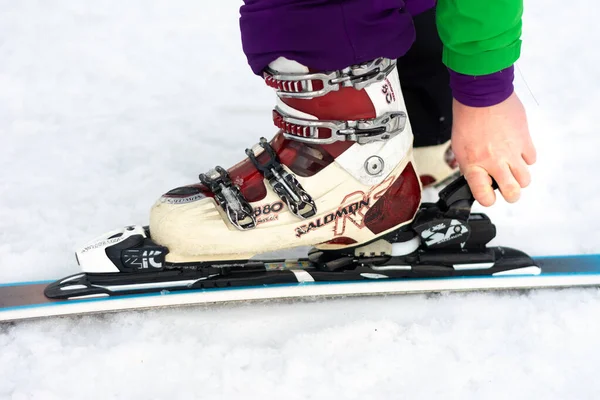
[{"left": 449, "top": 66, "right": 514, "bottom": 107}]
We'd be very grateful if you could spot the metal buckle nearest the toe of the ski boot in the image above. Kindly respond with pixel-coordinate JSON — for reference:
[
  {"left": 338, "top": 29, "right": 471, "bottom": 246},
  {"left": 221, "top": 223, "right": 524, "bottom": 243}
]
[{"left": 199, "top": 166, "right": 256, "bottom": 231}]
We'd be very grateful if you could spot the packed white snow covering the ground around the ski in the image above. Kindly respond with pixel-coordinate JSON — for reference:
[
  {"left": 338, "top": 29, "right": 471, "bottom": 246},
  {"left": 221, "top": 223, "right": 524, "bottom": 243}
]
[{"left": 0, "top": 0, "right": 600, "bottom": 400}]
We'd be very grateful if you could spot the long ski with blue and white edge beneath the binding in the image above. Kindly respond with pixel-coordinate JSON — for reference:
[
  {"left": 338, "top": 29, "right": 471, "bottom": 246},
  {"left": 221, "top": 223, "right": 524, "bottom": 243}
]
[{"left": 0, "top": 254, "right": 600, "bottom": 321}]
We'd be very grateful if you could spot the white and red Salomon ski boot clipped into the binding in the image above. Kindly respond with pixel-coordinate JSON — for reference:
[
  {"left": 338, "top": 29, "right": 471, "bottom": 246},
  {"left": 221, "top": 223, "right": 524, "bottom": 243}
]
[{"left": 149, "top": 58, "right": 422, "bottom": 263}]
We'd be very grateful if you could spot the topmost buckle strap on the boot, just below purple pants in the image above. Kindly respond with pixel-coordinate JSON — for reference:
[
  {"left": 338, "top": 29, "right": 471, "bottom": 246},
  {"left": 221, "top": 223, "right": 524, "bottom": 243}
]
[{"left": 263, "top": 57, "right": 396, "bottom": 98}]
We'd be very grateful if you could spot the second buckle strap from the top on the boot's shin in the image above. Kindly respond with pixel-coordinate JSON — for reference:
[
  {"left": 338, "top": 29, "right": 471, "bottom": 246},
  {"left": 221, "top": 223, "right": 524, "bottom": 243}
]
[{"left": 273, "top": 107, "right": 407, "bottom": 144}]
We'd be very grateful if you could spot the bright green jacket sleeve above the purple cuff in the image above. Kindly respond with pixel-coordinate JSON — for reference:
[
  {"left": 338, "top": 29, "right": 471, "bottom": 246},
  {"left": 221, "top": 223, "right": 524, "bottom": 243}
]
[{"left": 436, "top": 0, "right": 523, "bottom": 75}]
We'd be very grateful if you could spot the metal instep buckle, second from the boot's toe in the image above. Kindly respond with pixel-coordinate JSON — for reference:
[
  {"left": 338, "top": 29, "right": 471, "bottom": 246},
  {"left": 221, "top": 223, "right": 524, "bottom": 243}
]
[{"left": 246, "top": 137, "right": 317, "bottom": 219}]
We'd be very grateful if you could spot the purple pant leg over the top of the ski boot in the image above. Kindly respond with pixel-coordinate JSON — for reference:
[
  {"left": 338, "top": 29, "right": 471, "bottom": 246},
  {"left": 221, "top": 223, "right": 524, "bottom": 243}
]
[{"left": 240, "top": 0, "right": 415, "bottom": 74}]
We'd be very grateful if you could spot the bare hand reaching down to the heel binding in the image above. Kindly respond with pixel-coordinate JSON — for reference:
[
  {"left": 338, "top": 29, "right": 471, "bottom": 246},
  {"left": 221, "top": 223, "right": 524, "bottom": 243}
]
[{"left": 452, "top": 92, "right": 536, "bottom": 207}]
